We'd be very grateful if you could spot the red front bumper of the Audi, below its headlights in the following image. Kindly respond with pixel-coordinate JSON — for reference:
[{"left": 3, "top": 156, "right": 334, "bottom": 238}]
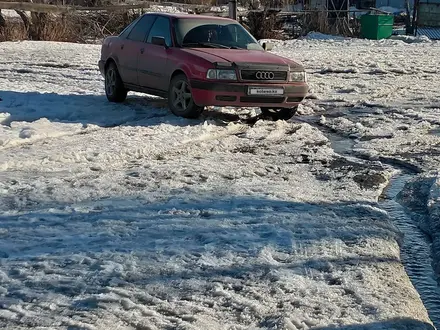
[{"left": 190, "top": 80, "right": 309, "bottom": 108}]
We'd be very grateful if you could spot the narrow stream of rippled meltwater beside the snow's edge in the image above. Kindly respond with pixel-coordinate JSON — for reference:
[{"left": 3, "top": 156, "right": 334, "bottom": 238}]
[{"left": 380, "top": 174, "right": 440, "bottom": 329}]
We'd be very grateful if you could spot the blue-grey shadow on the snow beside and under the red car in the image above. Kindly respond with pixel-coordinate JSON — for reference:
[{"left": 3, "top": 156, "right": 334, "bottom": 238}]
[{"left": 0, "top": 90, "right": 258, "bottom": 127}]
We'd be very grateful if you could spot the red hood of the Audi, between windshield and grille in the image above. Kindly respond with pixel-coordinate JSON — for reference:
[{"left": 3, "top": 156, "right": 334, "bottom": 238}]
[{"left": 180, "top": 48, "right": 303, "bottom": 69}]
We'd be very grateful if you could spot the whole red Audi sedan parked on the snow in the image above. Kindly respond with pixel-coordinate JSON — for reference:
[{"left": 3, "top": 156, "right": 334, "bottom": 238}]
[{"left": 99, "top": 13, "right": 308, "bottom": 119}]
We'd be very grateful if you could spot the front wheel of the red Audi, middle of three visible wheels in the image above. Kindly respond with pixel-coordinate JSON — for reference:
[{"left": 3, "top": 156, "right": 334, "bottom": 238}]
[{"left": 168, "top": 74, "right": 203, "bottom": 118}]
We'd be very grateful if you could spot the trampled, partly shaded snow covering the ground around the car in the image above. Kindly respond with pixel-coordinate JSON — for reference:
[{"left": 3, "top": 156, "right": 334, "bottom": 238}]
[{"left": 0, "top": 35, "right": 440, "bottom": 330}]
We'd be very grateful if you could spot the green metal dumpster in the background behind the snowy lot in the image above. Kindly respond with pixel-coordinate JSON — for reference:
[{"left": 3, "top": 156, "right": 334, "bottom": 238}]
[{"left": 361, "top": 14, "right": 394, "bottom": 40}]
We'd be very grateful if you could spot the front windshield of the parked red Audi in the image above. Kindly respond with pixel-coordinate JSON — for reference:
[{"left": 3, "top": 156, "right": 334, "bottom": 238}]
[{"left": 175, "top": 18, "right": 263, "bottom": 50}]
